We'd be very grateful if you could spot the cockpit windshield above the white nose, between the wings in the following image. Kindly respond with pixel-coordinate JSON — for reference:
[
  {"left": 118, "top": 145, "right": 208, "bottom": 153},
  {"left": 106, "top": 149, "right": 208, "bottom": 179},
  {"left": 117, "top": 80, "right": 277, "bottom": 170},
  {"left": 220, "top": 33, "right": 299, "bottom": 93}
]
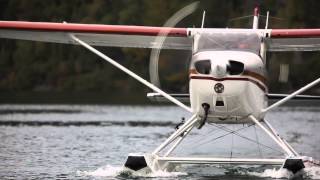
[{"left": 194, "top": 32, "right": 261, "bottom": 54}]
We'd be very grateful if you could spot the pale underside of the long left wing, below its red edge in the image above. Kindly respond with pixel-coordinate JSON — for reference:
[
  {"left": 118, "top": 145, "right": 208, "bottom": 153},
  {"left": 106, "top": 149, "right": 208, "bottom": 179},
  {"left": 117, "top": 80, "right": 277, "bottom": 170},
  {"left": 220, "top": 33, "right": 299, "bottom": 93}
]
[{"left": 0, "top": 30, "right": 192, "bottom": 50}]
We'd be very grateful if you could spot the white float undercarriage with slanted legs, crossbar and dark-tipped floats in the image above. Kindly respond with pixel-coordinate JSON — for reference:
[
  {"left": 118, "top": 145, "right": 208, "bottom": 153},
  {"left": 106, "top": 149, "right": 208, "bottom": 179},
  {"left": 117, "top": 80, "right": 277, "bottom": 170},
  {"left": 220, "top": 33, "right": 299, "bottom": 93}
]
[{"left": 124, "top": 114, "right": 315, "bottom": 174}]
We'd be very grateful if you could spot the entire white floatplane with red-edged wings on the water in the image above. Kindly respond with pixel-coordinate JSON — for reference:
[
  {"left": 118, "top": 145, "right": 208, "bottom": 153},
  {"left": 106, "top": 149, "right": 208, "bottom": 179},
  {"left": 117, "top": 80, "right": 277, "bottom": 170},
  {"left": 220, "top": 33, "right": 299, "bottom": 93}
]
[{"left": 0, "top": 3, "right": 320, "bottom": 176}]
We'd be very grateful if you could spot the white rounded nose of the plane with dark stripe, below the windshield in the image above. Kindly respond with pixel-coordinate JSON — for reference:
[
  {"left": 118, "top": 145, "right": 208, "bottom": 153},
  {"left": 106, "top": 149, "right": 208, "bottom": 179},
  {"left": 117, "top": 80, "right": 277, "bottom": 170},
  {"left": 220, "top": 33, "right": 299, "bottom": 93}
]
[{"left": 189, "top": 51, "right": 268, "bottom": 123}]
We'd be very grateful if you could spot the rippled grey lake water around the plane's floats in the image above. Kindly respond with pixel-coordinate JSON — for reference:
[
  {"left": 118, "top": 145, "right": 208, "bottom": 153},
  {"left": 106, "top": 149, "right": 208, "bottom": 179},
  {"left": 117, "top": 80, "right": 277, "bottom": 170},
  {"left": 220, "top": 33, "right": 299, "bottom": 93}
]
[{"left": 0, "top": 105, "right": 320, "bottom": 179}]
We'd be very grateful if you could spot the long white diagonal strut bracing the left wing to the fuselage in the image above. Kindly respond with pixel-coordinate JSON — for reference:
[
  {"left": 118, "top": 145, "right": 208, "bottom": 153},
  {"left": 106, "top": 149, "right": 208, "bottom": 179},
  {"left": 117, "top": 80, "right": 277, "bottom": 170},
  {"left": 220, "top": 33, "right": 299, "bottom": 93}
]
[{"left": 70, "top": 34, "right": 192, "bottom": 112}]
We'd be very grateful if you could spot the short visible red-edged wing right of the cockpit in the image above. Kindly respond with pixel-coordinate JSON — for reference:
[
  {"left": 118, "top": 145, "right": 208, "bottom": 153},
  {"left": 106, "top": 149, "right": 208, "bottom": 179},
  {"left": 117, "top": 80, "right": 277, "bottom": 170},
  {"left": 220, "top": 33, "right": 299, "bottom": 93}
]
[{"left": 267, "top": 29, "right": 320, "bottom": 52}]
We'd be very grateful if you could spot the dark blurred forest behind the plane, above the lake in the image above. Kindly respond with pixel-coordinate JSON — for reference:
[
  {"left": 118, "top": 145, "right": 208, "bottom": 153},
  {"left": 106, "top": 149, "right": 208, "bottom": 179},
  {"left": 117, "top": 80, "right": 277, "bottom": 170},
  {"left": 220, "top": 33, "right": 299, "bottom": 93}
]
[{"left": 0, "top": 0, "right": 320, "bottom": 104}]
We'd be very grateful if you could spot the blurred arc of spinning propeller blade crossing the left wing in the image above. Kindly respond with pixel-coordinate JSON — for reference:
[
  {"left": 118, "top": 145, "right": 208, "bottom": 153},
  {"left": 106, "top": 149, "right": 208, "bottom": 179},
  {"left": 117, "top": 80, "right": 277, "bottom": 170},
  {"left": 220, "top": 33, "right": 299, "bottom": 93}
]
[{"left": 149, "top": 1, "right": 199, "bottom": 87}]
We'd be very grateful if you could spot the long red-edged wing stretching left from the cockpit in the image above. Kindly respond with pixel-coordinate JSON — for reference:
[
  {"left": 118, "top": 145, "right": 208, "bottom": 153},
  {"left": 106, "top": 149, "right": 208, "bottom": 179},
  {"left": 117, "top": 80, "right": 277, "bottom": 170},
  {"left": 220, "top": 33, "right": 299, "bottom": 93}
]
[{"left": 0, "top": 21, "right": 192, "bottom": 50}]
